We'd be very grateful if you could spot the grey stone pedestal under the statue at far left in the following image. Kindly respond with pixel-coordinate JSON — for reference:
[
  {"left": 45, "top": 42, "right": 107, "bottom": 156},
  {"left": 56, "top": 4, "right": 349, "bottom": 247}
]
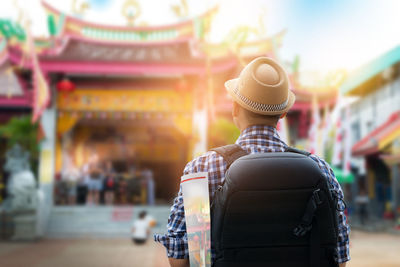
[{"left": 11, "top": 210, "right": 37, "bottom": 241}]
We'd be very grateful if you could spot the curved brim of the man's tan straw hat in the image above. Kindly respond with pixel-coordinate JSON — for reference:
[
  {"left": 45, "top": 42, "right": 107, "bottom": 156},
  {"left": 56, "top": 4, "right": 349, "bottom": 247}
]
[{"left": 225, "top": 78, "right": 296, "bottom": 115}]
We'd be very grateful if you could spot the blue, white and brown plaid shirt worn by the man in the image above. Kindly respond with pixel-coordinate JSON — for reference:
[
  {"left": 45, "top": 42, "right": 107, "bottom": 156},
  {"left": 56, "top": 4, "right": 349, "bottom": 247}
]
[{"left": 154, "top": 125, "right": 350, "bottom": 263}]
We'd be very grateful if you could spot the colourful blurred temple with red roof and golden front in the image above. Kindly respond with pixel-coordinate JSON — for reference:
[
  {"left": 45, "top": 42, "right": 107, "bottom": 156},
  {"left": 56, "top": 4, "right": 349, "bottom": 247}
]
[{"left": 0, "top": 2, "right": 337, "bottom": 203}]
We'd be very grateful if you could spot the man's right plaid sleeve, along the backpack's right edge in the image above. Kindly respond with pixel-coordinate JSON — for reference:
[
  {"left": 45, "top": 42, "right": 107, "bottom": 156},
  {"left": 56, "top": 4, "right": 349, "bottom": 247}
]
[{"left": 311, "top": 155, "right": 350, "bottom": 263}]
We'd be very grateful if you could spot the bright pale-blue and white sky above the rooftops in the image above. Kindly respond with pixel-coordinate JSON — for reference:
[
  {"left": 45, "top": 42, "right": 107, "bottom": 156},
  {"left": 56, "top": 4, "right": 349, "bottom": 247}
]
[{"left": 0, "top": 0, "right": 400, "bottom": 72}]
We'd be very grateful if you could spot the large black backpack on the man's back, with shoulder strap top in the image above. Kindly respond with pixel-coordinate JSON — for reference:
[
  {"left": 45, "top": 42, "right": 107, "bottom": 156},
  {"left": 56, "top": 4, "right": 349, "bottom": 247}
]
[{"left": 211, "top": 145, "right": 338, "bottom": 267}]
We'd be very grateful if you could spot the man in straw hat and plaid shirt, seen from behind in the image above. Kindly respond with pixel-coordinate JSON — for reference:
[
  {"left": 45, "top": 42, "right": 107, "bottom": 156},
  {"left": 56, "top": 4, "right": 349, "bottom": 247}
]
[{"left": 155, "top": 57, "right": 350, "bottom": 267}]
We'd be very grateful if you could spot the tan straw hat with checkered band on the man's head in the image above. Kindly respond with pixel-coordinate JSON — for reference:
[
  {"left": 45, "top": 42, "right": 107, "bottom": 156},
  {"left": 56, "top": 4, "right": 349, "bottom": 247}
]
[{"left": 225, "top": 57, "right": 296, "bottom": 115}]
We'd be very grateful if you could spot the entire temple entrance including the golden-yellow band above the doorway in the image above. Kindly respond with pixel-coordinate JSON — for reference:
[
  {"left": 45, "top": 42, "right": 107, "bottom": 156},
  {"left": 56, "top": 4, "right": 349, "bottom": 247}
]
[{"left": 54, "top": 85, "right": 196, "bottom": 205}]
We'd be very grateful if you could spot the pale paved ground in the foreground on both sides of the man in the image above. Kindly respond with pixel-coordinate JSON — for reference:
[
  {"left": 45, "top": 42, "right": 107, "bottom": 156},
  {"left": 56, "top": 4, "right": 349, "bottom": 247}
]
[{"left": 0, "top": 231, "right": 400, "bottom": 267}]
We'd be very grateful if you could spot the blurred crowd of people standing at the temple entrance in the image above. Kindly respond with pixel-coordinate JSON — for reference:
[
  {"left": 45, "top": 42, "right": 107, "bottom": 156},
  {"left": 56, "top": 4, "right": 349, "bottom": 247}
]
[{"left": 54, "top": 160, "right": 155, "bottom": 205}]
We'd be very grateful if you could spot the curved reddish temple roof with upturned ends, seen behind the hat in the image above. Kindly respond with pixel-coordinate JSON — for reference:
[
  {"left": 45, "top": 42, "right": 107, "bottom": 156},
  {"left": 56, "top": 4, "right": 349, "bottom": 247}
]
[{"left": 0, "top": 2, "right": 336, "bottom": 109}]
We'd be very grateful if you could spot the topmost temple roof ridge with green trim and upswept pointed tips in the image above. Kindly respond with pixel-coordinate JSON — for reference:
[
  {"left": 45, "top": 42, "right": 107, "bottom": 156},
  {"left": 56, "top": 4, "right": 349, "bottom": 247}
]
[{"left": 42, "top": 1, "right": 218, "bottom": 44}]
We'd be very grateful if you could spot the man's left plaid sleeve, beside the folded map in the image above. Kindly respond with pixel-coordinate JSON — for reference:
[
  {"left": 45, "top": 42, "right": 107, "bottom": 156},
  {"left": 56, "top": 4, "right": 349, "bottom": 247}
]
[{"left": 154, "top": 152, "right": 220, "bottom": 259}]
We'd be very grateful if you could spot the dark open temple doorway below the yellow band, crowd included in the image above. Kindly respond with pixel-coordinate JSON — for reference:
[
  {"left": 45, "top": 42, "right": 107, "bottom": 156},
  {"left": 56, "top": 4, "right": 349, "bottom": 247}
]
[{"left": 55, "top": 116, "right": 189, "bottom": 205}]
